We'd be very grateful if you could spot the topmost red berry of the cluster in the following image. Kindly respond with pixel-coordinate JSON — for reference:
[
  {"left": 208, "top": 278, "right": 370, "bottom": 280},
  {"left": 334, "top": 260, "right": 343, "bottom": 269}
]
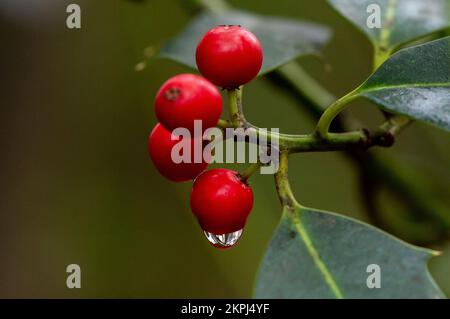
[{"left": 196, "top": 26, "right": 263, "bottom": 89}]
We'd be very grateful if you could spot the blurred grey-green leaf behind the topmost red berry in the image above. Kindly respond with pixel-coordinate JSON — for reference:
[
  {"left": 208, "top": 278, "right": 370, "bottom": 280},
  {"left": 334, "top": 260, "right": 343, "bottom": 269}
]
[{"left": 159, "top": 10, "right": 330, "bottom": 74}]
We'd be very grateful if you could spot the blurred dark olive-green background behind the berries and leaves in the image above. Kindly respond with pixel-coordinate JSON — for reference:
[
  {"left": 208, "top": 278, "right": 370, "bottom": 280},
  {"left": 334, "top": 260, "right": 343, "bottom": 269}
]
[{"left": 0, "top": 0, "right": 450, "bottom": 298}]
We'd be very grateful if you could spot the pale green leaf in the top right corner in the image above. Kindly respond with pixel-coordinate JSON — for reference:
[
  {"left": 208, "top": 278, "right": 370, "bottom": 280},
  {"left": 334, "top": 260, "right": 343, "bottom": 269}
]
[{"left": 328, "top": 0, "right": 450, "bottom": 52}]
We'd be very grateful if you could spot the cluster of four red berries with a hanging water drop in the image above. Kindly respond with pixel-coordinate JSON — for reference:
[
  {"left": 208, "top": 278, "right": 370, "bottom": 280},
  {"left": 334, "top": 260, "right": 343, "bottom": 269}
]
[{"left": 148, "top": 25, "right": 263, "bottom": 248}]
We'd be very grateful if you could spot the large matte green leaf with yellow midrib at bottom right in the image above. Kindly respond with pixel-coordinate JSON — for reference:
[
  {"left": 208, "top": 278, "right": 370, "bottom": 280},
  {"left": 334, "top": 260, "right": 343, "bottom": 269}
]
[{"left": 255, "top": 207, "right": 445, "bottom": 299}]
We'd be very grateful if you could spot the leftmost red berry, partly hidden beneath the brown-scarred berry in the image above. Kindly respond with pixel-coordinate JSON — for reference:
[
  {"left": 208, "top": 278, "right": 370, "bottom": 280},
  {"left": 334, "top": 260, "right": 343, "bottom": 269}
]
[{"left": 147, "top": 123, "right": 208, "bottom": 182}]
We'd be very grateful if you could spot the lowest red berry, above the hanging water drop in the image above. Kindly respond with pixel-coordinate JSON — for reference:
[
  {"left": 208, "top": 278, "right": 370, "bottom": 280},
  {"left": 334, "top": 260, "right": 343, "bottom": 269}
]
[{"left": 191, "top": 169, "right": 253, "bottom": 235}]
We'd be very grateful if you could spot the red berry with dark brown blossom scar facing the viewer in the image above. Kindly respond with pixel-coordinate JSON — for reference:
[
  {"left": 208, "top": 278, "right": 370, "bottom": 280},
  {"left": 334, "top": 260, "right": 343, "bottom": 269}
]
[{"left": 155, "top": 74, "right": 222, "bottom": 132}]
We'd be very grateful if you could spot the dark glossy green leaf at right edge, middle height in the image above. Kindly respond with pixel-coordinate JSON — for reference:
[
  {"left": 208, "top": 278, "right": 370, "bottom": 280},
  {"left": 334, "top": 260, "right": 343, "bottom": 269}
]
[{"left": 353, "top": 37, "right": 450, "bottom": 131}]
